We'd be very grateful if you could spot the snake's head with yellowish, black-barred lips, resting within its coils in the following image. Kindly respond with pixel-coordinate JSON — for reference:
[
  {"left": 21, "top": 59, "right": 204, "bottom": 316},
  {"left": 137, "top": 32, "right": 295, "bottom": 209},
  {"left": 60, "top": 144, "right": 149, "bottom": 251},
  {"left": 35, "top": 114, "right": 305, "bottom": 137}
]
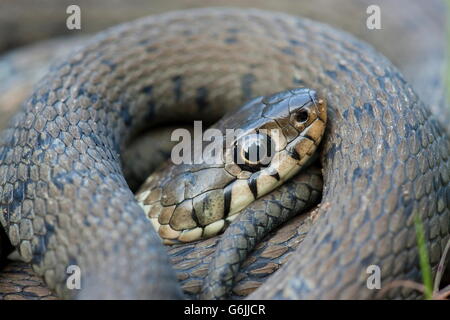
[{"left": 137, "top": 88, "right": 327, "bottom": 243}]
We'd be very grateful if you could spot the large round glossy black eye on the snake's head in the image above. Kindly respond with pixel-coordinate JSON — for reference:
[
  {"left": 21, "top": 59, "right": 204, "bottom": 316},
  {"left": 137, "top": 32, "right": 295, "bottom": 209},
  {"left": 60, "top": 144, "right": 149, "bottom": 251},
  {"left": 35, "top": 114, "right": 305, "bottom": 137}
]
[{"left": 234, "top": 133, "right": 275, "bottom": 171}]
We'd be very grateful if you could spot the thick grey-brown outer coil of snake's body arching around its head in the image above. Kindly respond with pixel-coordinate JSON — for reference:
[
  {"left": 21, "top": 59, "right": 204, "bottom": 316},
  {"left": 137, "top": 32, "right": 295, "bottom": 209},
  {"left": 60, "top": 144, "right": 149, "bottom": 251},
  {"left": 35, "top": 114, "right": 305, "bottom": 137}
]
[{"left": 0, "top": 0, "right": 449, "bottom": 299}]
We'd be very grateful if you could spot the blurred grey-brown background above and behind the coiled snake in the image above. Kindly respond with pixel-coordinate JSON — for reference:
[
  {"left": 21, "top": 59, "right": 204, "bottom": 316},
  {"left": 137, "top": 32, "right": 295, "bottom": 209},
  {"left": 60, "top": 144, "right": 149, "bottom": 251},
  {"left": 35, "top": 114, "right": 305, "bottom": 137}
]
[{"left": 0, "top": 0, "right": 444, "bottom": 127}]
